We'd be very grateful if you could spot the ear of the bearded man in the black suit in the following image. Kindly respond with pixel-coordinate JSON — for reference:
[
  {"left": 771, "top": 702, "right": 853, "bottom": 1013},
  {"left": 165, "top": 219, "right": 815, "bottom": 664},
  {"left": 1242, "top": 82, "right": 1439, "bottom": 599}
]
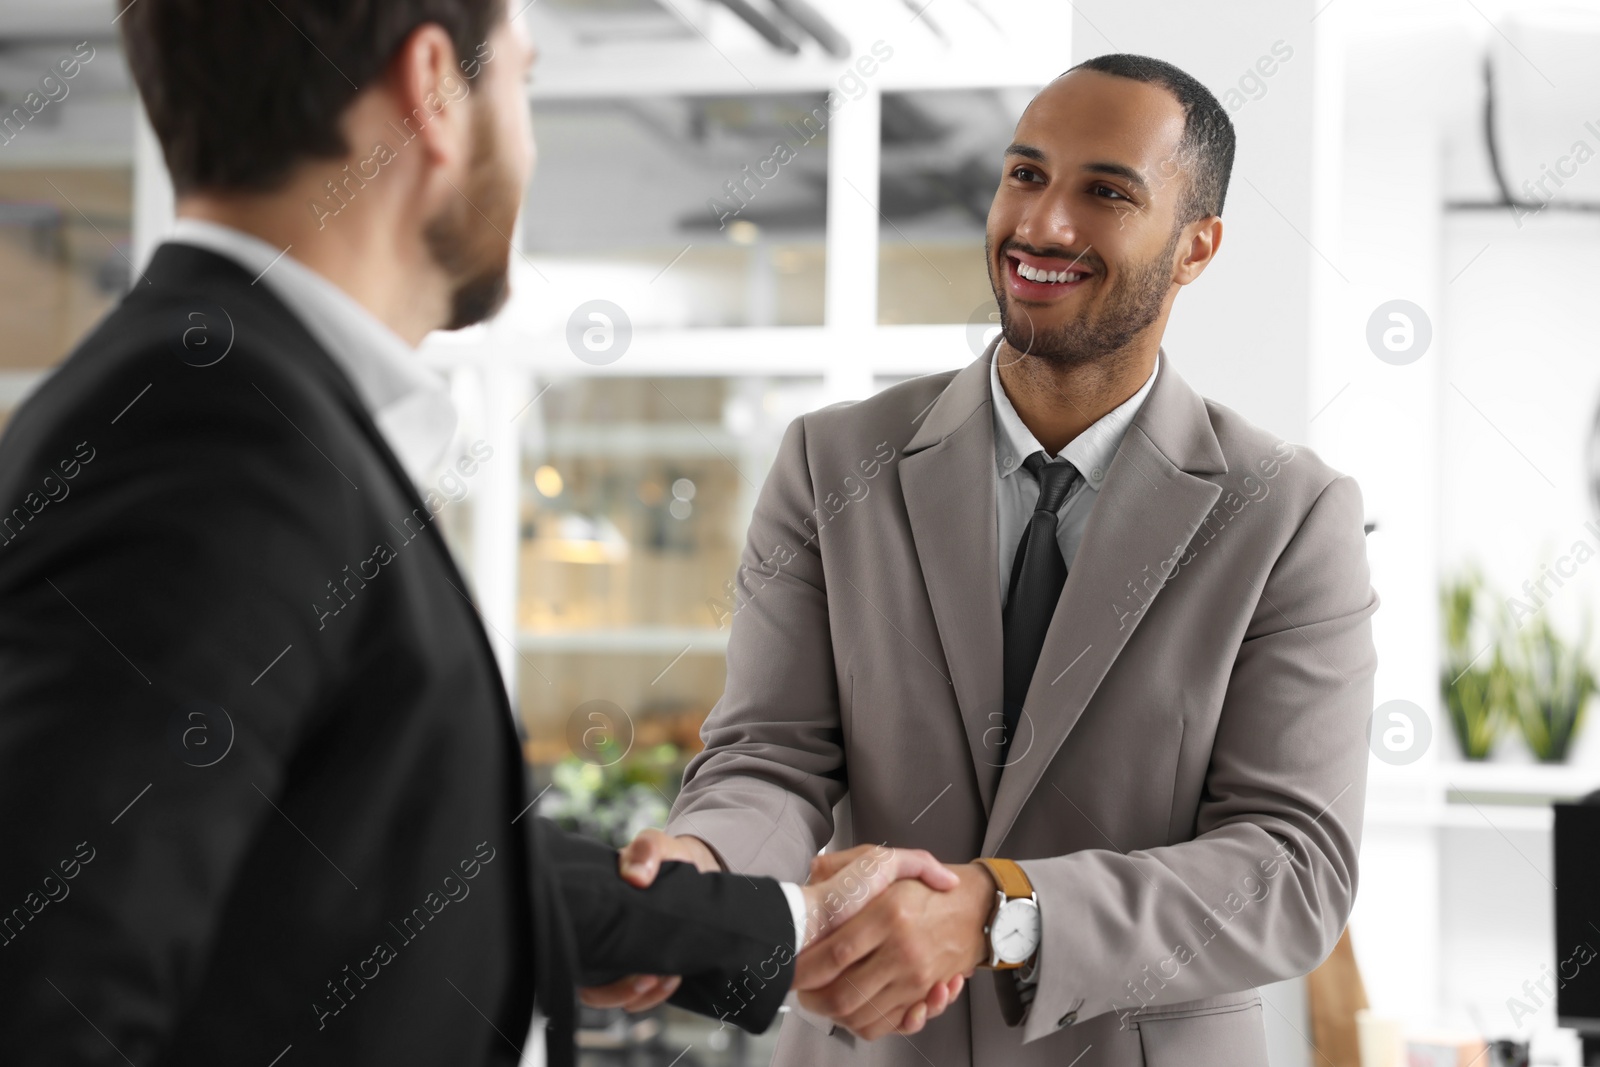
[{"left": 386, "top": 22, "right": 472, "bottom": 174}]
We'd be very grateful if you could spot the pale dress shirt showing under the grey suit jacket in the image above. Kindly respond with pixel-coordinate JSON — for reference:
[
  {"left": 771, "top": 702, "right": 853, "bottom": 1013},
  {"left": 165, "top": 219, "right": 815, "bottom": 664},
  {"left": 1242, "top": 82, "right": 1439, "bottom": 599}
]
[{"left": 989, "top": 349, "right": 1162, "bottom": 1005}]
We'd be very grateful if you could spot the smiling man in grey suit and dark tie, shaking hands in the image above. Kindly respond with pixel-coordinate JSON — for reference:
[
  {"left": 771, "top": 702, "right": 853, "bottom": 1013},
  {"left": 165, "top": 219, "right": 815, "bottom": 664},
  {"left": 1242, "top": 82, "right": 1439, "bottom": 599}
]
[{"left": 604, "top": 56, "right": 1378, "bottom": 1067}]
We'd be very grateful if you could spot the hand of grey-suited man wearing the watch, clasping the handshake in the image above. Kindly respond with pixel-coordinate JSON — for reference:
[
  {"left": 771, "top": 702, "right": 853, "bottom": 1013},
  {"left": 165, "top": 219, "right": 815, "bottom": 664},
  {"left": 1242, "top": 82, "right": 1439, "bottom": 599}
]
[{"left": 794, "top": 857, "right": 995, "bottom": 1041}]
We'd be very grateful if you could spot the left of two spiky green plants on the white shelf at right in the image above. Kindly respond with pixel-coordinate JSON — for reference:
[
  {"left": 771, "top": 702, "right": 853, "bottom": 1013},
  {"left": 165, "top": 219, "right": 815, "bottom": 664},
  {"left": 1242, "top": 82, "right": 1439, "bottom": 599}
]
[{"left": 1438, "top": 568, "right": 1510, "bottom": 760}]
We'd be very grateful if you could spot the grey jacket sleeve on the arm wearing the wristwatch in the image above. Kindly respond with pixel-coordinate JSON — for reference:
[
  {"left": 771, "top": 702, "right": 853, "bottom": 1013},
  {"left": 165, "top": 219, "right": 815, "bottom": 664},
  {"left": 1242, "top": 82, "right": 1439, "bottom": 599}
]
[{"left": 1022, "top": 477, "right": 1378, "bottom": 1041}]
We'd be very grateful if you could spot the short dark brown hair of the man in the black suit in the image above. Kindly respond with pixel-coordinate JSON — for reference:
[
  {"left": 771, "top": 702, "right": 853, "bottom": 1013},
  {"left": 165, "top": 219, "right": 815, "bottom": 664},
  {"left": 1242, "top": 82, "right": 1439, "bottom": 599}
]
[{"left": 122, "top": 0, "right": 507, "bottom": 194}]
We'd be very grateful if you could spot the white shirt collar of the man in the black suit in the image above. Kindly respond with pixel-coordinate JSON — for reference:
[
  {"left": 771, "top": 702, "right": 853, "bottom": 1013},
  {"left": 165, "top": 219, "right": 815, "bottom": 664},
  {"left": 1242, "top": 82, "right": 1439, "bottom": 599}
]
[{"left": 168, "top": 219, "right": 458, "bottom": 486}]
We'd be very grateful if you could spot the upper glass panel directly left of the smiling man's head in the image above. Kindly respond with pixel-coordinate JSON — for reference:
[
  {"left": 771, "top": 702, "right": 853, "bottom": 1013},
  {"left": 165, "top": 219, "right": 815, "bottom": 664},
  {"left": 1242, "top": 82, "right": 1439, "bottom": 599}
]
[{"left": 878, "top": 88, "right": 1035, "bottom": 325}]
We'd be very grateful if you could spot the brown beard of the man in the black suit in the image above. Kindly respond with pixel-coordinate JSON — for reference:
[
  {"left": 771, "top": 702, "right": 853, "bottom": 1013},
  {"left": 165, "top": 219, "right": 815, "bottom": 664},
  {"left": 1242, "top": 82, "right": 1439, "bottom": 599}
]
[{"left": 422, "top": 101, "right": 522, "bottom": 330}]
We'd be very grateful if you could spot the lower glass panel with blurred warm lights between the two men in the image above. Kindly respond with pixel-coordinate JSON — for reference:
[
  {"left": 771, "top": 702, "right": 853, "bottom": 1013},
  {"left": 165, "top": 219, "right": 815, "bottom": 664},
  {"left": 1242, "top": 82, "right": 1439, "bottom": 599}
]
[{"left": 518, "top": 378, "right": 824, "bottom": 777}]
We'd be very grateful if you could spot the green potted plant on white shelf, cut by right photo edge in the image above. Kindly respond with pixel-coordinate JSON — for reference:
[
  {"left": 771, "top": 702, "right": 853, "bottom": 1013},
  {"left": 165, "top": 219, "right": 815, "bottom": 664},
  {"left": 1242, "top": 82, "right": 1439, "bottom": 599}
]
[{"left": 1507, "top": 613, "right": 1600, "bottom": 763}]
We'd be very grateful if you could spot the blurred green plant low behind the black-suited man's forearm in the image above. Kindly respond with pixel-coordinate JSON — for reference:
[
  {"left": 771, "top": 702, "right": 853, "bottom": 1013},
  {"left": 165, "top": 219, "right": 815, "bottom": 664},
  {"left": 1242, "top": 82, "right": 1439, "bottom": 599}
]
[{"left": 539, "top": 737, "right": 683, "bottom": 848}]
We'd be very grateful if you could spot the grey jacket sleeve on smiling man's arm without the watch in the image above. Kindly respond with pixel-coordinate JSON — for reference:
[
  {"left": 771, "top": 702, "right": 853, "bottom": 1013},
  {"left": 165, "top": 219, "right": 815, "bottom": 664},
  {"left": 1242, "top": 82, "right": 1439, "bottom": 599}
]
[{"left": 667, "top": 418, "right": 845, "bottom": 881}]
